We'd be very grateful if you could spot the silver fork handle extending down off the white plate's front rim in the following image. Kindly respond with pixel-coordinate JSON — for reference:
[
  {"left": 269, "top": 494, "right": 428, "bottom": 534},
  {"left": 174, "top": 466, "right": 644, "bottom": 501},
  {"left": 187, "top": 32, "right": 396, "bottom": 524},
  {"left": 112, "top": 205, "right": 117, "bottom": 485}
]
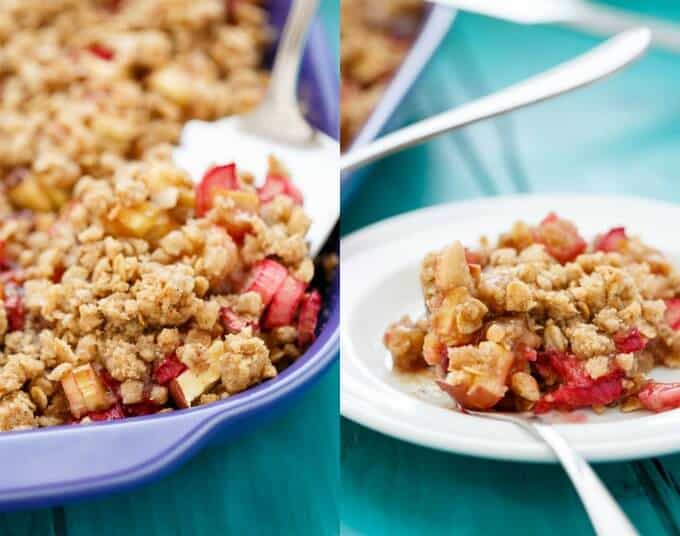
[{"left": 531, "top": 423, "right": 639, "bottom": 536}]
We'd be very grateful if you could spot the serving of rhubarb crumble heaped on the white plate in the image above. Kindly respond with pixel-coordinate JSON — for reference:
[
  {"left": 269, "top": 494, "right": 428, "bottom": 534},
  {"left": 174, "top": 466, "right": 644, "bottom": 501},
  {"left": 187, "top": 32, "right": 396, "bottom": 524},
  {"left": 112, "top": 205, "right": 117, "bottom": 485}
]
[{"left": 384, "top": 214, "right": 680, "bottom": 414}]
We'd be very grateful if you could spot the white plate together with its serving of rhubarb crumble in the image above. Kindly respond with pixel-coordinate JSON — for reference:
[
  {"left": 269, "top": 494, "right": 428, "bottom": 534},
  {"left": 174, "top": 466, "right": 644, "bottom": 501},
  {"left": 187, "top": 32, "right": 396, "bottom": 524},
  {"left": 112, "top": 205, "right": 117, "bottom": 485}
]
[{"left": 341, "top": 194, "right": 680, "bottom": 461}]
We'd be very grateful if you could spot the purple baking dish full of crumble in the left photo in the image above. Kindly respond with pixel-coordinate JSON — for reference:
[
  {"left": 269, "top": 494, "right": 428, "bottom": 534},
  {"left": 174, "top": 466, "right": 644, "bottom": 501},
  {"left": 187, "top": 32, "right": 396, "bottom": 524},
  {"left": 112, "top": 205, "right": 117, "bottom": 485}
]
[{"left": 0, "top": 0, "right": 339, "bottom": 510}]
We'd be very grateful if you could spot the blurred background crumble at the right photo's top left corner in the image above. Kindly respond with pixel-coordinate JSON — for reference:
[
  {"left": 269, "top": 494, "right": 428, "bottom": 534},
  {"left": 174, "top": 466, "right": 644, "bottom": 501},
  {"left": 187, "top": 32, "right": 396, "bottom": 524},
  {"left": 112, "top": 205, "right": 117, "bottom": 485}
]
[{"left": 340, "top": 0, "right": 425, "bottom": 148}]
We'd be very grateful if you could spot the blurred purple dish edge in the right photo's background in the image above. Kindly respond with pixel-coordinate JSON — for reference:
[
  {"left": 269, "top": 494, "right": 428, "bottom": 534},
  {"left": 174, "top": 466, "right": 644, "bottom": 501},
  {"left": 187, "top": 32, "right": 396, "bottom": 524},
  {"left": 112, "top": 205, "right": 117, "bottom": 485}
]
[{"left": 341, "top": 5, "right": 456, "bottom": 206}]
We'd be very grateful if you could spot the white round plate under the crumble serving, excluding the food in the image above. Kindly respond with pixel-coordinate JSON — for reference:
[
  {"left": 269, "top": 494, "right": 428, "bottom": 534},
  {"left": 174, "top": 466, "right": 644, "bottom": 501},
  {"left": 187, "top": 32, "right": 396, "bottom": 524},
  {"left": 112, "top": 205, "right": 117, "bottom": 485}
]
[{"left": 341, "top": 195, "right": 680, "bottom": 461}]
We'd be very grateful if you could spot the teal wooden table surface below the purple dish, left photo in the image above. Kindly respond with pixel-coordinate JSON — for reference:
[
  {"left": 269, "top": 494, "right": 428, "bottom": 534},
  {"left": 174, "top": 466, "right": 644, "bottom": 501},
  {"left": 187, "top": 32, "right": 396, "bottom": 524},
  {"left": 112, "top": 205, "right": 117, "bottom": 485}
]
[{"left": 0, "top": 4, "right": 340, "bottom": 536}]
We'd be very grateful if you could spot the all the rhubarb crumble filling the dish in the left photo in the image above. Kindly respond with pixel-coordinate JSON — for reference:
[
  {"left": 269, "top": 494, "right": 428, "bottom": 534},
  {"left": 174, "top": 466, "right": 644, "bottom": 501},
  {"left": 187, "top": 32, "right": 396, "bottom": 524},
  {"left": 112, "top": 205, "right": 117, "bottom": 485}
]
[{"left": 0, "top": 0, "right": 330, "bottom": 431}]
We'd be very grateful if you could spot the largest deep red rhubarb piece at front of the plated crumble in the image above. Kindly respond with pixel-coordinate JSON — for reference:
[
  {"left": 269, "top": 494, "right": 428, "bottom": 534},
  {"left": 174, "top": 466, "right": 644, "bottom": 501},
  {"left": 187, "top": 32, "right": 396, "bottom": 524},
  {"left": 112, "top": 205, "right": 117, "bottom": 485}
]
[{"left": 534, "top": 370, "right": 623, "bottom": 413}]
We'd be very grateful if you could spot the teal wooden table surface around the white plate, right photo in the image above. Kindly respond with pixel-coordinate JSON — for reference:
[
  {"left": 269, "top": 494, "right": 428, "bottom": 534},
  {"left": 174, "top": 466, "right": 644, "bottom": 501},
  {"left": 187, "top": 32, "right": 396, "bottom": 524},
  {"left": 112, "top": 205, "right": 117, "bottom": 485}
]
[{"left": 341, "top": 2, "right": 680, "bottom": 536}]
